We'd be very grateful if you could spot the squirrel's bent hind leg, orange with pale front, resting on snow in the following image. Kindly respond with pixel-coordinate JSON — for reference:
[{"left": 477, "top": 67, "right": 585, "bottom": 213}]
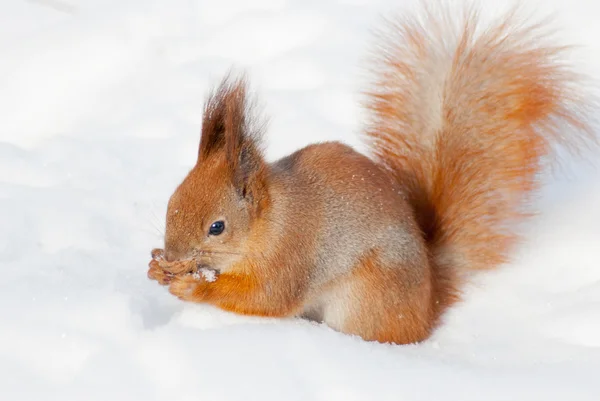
[{"left": 323, "top": 254, "right": 434, "bottom": 344}]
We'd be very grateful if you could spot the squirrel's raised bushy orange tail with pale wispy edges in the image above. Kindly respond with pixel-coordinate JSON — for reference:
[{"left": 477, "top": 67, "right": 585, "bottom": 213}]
[{"left": 366, "top": 5, "right": 593, "bottom": 272}]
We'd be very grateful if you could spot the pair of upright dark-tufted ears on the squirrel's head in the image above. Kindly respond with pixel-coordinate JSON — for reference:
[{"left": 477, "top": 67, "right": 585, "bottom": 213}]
[{"left": 198, "top": 75, "right": 267, "bottom": 211}]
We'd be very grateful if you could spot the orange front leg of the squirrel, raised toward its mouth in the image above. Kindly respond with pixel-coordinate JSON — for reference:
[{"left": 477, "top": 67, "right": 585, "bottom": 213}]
[{"left": 169, "top": 269, "right": 299, "bottom": 317}]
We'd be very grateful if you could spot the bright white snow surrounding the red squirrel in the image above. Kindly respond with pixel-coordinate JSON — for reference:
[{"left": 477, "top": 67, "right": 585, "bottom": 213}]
[{"left": 0, "top": 0, "right": 600, "bottom": 401}]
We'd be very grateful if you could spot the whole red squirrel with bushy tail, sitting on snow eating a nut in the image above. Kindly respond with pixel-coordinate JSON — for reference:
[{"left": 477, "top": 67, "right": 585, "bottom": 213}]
[{"left": 148, "top": 3, "right": 593, "bottom": 344}]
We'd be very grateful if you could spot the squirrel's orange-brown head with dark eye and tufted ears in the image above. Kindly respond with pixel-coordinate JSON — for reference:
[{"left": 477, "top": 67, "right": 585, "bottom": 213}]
[{"left": 165, "top": 78, "right": 269, "bottom": 270}]
